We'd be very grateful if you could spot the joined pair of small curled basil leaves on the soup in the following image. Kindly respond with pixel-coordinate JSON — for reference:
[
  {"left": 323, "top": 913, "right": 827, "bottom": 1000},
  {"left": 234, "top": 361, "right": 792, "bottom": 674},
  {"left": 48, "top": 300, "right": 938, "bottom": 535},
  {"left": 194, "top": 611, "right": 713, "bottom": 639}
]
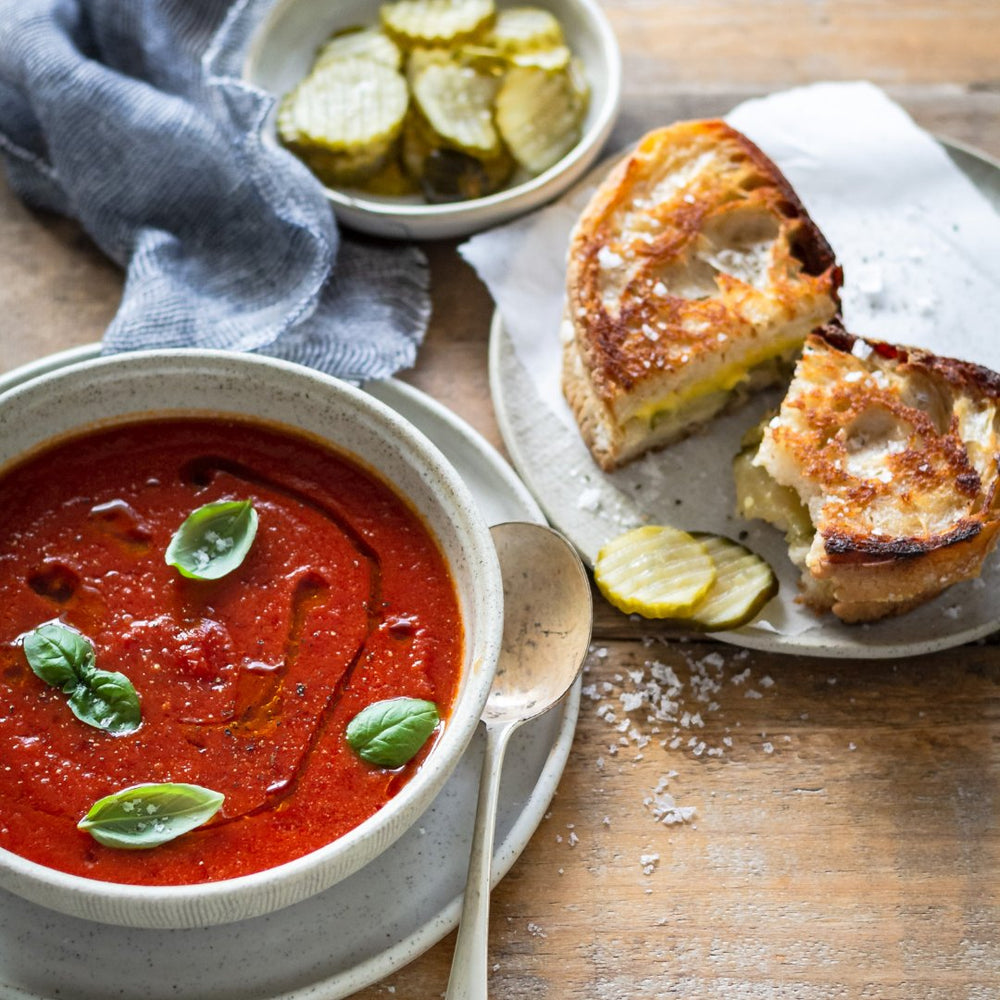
[{"left": 22, "top": 621, "right": 142, "bottom": 736}]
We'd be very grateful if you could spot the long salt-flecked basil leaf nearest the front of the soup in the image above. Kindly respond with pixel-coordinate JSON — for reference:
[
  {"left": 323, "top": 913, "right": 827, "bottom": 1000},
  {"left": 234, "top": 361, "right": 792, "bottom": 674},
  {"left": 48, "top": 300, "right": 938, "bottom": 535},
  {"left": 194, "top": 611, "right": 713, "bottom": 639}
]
[{"left": 76, "top": 784, "right": 225, "bottom": 851}]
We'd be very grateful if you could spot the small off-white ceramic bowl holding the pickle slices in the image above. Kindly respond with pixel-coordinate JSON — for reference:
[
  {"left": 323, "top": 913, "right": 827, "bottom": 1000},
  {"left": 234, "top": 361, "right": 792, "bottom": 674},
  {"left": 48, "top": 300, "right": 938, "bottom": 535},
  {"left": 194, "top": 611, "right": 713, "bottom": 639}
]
[{"left": 243, "top": 0, "right": 621, "bottom": 240}]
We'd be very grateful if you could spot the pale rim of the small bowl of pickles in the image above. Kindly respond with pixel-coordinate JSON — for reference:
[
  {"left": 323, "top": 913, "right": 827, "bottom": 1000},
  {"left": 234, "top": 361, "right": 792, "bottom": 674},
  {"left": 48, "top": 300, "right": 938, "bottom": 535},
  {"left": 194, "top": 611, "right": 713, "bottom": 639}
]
[{"left": 242, "top": 0, "right": 622, "bottom": 236}]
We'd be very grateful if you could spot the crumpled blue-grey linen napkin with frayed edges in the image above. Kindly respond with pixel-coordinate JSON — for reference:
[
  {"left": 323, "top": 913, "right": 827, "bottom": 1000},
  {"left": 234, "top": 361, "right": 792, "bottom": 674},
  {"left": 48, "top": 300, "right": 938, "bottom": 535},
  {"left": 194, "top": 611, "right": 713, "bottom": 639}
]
[{"left": 0, "top": 0, "right": 430, "bottom": 382}]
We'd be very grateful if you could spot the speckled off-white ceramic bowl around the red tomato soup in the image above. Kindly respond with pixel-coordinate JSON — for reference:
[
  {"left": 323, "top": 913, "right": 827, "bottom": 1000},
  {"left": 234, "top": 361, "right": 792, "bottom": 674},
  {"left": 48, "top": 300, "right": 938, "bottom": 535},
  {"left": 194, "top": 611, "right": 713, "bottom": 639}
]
[{"left": 0, "top": 350, "right": 503, "bottom": 928}]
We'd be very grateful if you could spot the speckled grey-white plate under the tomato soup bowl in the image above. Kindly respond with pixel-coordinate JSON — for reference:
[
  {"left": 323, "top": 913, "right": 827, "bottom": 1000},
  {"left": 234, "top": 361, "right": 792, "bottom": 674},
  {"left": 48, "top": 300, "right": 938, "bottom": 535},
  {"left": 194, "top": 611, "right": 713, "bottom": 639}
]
[{"left": 0, "top": 346, "right": 580, "bottom": 1000}]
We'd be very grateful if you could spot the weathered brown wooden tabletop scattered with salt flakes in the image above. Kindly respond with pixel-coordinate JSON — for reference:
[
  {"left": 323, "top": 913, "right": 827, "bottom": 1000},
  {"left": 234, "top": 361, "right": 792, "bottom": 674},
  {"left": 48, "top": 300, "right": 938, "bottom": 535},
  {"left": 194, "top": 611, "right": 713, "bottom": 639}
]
[{"left": 0, "top": 0, "right": 1000, "bottom": 1000}]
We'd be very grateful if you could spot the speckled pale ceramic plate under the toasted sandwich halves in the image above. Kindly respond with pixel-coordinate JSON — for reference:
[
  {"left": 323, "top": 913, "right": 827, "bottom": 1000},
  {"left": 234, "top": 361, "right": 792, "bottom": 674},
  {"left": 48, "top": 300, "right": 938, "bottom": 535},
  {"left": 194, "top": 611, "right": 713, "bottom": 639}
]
[{"left": 490, "top": 143, "right": 1000, "bottom": 658}]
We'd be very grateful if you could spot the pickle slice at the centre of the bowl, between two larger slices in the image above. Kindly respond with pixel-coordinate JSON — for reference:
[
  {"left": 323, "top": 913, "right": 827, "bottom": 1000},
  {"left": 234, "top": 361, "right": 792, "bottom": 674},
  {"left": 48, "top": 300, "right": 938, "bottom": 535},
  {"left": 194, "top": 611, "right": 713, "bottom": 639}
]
[{"left": 413, "top": 62, "right": 501, "bottom": 157}]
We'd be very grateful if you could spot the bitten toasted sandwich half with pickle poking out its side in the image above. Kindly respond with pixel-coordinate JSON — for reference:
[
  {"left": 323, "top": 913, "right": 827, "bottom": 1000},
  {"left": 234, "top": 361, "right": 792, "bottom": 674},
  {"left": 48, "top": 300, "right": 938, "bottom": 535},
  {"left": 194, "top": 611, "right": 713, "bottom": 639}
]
[{"left": 736, "top": 326, "right": 1000, "bottom": 622}]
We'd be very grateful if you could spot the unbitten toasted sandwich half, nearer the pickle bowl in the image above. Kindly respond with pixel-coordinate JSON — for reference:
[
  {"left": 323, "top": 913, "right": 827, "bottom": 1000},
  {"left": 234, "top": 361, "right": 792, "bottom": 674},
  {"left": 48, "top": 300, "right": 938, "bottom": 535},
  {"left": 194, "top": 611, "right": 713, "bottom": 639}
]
[{"left": 562, "top": 121, "right": 841, "bottom": 469}]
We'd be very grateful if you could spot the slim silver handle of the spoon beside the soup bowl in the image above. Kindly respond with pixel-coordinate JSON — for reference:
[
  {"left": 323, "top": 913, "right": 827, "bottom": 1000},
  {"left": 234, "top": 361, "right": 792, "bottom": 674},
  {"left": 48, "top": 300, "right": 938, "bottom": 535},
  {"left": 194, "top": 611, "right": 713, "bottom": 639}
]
[{"left": 445, "top": 722, "right": 517, "bottom": 1000}]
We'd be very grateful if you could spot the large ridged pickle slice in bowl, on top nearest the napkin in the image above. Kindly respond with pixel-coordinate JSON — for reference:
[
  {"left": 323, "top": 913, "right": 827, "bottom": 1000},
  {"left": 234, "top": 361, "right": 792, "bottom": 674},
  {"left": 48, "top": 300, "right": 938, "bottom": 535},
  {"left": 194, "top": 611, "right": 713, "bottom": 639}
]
[{"left": 278, "top": 59, "right": 409, "bottom": 159}]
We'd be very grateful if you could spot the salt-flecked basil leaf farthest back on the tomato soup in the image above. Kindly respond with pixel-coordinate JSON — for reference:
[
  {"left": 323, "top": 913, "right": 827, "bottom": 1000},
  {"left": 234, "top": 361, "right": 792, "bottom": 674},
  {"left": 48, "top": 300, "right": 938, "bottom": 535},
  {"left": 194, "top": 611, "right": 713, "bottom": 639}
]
[{"left": 165, "top": 500, "right": 257, "bottom": 580}]
